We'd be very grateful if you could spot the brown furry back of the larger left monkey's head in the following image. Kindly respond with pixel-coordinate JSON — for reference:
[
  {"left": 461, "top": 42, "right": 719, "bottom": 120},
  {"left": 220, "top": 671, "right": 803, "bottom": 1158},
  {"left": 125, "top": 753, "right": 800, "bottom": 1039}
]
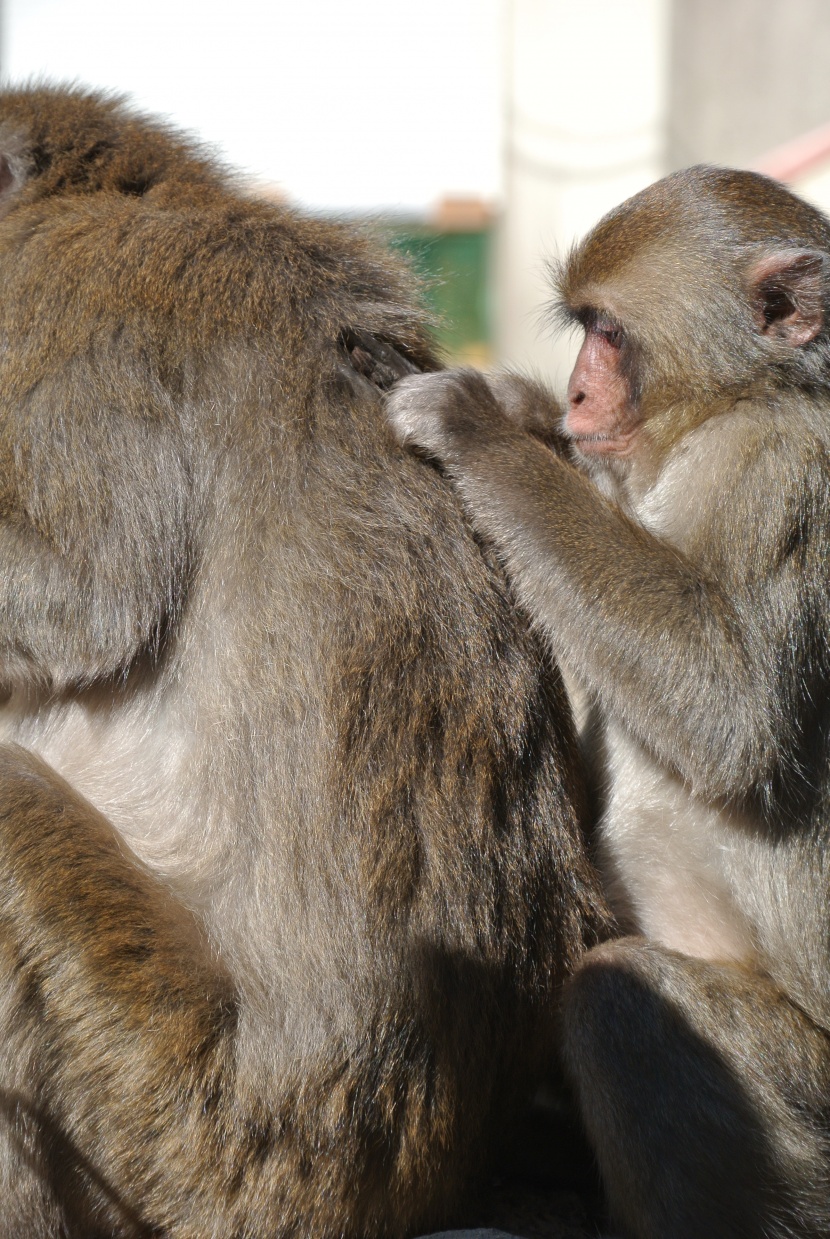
[{"left": 0, "top": 87, "right": 224, "bottom": 213}]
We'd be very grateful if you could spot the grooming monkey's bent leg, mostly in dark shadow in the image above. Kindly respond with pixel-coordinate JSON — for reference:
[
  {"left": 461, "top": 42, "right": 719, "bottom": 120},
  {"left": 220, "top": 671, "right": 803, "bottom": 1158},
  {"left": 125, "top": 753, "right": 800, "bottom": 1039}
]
[{"left": 564, "top": 938, "right": 830, "bottom": 1239}]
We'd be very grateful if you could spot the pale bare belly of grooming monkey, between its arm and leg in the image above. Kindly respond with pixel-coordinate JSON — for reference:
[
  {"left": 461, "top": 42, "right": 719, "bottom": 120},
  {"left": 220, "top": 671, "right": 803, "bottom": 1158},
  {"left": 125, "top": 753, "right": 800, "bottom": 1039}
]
[{"left": 600, "top": 725, "right": 756, "bottom": 964}]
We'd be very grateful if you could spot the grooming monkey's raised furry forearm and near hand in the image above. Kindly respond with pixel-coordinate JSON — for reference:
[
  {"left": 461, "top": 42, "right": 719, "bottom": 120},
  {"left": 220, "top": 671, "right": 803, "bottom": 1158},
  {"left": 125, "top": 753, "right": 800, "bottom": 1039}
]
[{"left": 389, "top": 372, "right": 817, "bottom": 798}]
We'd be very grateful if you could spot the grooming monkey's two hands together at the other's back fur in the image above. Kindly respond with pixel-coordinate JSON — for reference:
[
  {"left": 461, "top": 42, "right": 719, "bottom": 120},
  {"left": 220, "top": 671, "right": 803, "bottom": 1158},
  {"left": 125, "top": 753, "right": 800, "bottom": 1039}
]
[{"left": 387, "top": 369, "right": 565, "bottom": 470}]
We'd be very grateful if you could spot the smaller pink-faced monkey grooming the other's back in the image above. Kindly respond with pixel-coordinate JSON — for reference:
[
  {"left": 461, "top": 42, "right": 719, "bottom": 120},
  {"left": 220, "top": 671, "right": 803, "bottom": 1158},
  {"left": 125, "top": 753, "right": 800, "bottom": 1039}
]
[{"left": 388, "top": 166, "right": 830, "bottom": 1239}]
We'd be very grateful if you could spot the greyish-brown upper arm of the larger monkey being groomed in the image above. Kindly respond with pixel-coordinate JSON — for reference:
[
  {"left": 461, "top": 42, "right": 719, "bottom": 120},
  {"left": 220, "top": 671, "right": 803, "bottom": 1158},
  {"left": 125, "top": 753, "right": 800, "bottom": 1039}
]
[{"left": 0, "top": 370, "right": 193, "bottom": 690}]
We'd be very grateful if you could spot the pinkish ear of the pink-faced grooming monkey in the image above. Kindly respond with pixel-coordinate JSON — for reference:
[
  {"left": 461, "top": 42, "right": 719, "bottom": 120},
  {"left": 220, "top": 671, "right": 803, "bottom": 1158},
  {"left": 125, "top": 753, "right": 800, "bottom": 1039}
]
[{"left": 749, "top": 249, "right": 825, "bottom": 348}]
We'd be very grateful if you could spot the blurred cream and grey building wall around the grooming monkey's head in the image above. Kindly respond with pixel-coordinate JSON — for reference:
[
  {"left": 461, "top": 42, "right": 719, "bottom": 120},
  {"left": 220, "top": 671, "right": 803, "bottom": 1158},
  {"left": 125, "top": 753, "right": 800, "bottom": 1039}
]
[{"left": 494, "top": 0, "right": 830, "bottom": 387}]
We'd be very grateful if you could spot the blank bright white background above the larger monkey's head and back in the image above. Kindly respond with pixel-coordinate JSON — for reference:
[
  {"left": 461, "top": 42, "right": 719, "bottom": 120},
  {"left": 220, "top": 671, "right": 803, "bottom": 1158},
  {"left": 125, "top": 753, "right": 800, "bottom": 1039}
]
[{"left": 0, "top": 0, "right": 502, "bottom": 211}]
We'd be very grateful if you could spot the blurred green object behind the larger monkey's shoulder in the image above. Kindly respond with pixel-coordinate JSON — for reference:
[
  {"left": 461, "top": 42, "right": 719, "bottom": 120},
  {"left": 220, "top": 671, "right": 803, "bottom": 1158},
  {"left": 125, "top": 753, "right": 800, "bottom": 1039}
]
[{"left": 388, "top": 222, "right": 492, "bottom": 366}]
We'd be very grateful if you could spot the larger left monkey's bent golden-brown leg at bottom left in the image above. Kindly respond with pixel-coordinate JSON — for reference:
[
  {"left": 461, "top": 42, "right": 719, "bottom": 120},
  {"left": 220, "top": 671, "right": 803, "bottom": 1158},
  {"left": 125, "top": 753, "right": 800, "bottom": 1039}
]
[{"left": 0, "top": 747, "right": 244, "bottom": 1239}]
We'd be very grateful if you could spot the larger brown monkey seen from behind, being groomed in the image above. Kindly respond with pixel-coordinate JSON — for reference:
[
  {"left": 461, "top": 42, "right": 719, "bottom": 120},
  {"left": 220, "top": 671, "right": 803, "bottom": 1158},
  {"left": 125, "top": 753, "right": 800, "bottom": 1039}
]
[{"left": 0, "top": 85, "right": 612, "bottom": 1239}]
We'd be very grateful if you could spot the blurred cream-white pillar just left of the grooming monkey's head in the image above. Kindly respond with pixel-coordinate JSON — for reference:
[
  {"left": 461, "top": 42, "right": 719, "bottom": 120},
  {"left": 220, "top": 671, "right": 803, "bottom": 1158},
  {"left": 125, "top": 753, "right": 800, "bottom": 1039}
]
[{"left": 494, "top": 0, "right": 669, "bottom": 389}]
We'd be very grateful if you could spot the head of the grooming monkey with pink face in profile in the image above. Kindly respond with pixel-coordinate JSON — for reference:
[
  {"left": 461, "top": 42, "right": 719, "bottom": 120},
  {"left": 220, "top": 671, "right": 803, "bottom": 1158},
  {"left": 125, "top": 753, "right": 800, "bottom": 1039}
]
[{"left": 556, "top": 167, "right": 830, "bottom": 463}]
